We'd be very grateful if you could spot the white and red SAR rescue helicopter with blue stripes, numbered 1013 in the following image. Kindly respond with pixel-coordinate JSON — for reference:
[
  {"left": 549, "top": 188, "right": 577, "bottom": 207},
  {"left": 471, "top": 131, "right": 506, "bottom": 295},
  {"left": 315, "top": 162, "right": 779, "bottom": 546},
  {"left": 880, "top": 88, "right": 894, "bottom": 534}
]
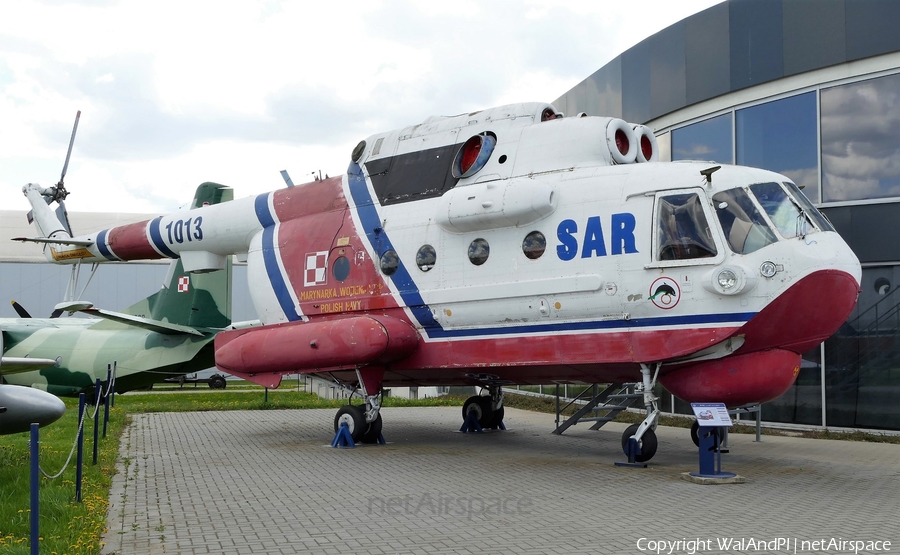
[{"left": 17, "top": 103, "right": 861, "bottom": 460}]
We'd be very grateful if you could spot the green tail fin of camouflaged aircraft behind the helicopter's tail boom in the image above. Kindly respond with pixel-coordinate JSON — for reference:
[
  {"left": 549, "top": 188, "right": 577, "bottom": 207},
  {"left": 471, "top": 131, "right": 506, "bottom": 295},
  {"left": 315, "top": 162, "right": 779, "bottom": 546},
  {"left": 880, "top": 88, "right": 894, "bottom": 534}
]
[{"left": 123, "top": 182, "right": 234, "bottom": 328}]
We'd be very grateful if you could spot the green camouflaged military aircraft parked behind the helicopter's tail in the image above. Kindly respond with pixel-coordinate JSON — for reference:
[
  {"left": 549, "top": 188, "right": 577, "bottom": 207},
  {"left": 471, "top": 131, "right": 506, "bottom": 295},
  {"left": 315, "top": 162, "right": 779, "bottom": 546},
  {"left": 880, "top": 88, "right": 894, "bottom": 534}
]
[{"left": 0, "top": 183, "right": 233, "bottom": 395}]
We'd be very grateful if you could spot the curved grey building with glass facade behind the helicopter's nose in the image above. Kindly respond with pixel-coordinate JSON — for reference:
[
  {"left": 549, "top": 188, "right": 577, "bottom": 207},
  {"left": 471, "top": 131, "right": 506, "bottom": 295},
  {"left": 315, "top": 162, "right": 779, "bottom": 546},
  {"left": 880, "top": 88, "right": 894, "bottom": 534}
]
[{"left": 554, "top": 0, "right": 900, "bottom": 430}]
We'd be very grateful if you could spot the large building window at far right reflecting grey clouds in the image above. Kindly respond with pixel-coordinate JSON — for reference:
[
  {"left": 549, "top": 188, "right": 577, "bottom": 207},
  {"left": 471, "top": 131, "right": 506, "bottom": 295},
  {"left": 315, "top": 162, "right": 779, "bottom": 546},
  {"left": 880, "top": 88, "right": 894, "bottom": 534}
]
[{"left": 821, "top": 75, "right": 900, "bottom": 202}]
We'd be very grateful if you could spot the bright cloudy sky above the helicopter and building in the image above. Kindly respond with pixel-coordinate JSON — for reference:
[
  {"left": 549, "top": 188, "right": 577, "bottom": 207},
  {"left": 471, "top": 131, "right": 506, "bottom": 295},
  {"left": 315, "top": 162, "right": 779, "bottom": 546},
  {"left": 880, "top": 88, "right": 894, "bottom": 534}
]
[{"left": 0, "top": 0, "right": 721, "bottom": 215}]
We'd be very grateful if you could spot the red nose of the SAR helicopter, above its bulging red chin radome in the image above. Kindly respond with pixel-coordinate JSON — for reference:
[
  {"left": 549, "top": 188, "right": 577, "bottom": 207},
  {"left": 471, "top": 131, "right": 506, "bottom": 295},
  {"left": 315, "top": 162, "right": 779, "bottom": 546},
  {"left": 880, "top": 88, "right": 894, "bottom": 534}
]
[{"left": 737, "top": 270, "right": 859, "bottom": 353}]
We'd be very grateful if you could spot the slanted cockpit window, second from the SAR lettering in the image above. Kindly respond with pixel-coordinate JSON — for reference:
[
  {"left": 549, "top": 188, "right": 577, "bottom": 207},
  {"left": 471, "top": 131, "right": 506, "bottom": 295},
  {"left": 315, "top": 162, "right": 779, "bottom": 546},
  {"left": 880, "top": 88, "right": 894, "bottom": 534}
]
[{"left": 713, "top": 189, "right": 778, "bottom": 254}]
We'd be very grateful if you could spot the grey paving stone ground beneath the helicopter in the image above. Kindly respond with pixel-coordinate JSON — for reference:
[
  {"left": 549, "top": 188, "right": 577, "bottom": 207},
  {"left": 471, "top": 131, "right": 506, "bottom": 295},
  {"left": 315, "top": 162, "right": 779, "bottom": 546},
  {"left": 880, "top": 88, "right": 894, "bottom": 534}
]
[{"left": 103, "top": 407, "right": 900, "bottom": 555}]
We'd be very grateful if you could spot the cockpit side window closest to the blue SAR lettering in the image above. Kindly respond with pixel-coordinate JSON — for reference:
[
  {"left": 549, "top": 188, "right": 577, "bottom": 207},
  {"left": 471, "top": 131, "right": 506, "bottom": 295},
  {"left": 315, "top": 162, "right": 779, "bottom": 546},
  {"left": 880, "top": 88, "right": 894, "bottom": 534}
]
[{"left": 657, "top": 193, "right": 717, "bottom": 260}]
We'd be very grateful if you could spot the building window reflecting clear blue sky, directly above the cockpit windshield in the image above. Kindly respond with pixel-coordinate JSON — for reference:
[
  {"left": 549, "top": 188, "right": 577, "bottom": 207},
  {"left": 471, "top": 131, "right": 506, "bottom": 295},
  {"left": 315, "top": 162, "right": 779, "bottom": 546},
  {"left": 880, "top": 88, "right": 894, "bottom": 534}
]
[{"left": 735, "top": 92, "right": 819, "bottom": 202}]
